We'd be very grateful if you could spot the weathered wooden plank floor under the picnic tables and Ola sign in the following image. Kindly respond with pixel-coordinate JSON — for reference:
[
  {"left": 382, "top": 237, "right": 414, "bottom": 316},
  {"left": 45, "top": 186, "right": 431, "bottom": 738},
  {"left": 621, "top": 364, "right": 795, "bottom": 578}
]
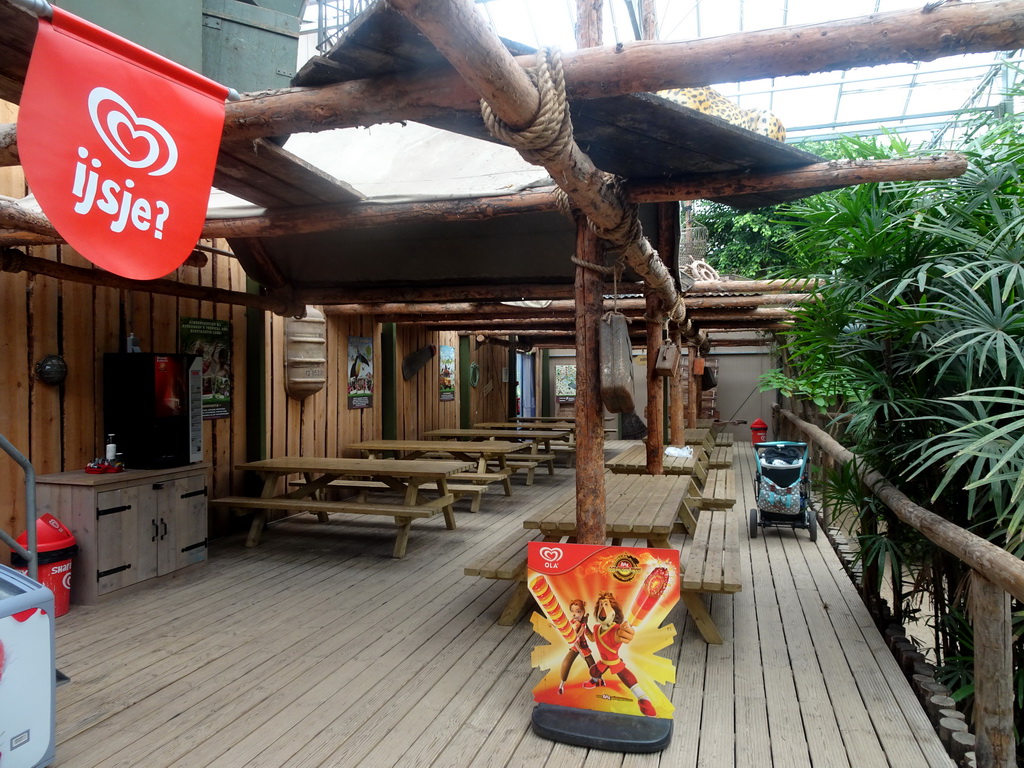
[{"left": 49, "top": 442, "right": 952, "bottom": 768}]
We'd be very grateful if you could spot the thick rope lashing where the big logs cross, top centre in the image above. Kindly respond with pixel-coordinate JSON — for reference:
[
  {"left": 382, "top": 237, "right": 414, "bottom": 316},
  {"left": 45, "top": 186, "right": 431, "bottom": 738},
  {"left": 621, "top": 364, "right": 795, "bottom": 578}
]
[{"left": 480, "top": 48, "right": 572, "bottom": 165}]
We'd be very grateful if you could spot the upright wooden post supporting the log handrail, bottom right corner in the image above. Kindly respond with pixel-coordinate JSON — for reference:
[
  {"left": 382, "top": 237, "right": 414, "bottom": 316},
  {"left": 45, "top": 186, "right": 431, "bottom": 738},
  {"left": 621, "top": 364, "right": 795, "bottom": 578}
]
[{"left": 970, "top": 570, "right": 1017, "bottom": 768}]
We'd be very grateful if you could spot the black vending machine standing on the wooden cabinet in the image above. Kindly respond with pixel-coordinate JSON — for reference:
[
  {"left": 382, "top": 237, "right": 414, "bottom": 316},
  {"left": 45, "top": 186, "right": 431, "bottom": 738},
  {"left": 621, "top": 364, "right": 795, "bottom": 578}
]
[{"left": 103, "top": 352, "right": 203, "bottom": 469}]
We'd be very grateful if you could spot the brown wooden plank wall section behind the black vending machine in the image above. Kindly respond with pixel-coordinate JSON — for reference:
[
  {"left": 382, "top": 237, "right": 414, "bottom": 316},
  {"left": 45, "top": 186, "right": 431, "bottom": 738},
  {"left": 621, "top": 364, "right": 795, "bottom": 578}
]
[{"left": 0, "top": 102, "right": 246, "bottom": 562}]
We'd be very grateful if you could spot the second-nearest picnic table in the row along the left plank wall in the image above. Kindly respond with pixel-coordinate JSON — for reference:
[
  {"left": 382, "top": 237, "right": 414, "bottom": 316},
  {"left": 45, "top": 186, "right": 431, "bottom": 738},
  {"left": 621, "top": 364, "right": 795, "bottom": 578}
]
[{"left": 349, "top": 439, "right": 529, "bottom": 501}]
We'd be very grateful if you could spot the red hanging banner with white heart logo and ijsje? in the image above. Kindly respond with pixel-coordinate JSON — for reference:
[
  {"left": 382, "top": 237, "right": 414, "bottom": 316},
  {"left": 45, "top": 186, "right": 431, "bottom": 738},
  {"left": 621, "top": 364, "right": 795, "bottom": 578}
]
[{"left": 17, "top": 8, "right": 227, "bottom": 280}]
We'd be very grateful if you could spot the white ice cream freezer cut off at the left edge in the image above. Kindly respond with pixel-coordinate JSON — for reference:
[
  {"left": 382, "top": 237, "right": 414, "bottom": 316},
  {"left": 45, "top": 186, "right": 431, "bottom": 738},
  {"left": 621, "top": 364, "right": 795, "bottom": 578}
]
[{"left": 0, "top": 564, "right": 56, "bottom": 768}]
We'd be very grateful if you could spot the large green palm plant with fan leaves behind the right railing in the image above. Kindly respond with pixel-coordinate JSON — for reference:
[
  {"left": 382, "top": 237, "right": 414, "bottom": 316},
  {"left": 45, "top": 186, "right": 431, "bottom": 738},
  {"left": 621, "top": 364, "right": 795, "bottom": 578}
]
[{"left": 765, "top": 121, "right": 1024, "bottom": 741}]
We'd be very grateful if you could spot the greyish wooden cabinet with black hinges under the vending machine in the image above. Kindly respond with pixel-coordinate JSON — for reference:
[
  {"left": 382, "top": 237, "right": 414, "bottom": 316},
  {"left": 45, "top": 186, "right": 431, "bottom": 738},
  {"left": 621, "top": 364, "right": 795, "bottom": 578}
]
[{"left": 36, "top": 464, "right": 209, "bottom": 605}]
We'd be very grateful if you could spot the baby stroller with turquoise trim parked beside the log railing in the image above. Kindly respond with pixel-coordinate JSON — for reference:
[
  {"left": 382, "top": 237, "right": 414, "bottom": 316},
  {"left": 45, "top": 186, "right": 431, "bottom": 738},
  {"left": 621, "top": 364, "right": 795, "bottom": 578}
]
[{"left": 751, "top": 440, "right": 818, "bottom": 542}]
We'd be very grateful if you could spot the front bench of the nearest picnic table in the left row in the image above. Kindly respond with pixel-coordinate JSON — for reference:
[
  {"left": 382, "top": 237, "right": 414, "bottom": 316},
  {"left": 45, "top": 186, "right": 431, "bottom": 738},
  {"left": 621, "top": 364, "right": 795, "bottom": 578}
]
[{"left": 210, "top": 494, "right": 455, "bottom": 557}]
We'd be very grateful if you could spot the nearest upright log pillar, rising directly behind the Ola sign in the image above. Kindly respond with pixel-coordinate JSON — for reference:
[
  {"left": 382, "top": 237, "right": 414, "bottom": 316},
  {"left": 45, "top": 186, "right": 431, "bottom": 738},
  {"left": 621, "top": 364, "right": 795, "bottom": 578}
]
[{"left": 575, "top": 216, "right": 605, "bottom": 544}]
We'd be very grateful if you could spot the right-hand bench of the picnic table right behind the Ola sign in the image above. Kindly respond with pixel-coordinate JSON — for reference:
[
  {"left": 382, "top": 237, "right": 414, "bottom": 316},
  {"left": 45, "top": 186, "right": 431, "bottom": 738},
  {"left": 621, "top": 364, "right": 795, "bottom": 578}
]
[{"left": 680, "top": 509, "right": 742, "bottom": 645}]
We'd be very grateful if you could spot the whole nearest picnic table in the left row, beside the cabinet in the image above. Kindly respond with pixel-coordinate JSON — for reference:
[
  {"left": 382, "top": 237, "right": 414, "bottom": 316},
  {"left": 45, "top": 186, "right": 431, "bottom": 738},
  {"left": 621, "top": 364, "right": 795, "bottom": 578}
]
[{"left": 210, "top": 456, "right": 474, "bottom": 557}]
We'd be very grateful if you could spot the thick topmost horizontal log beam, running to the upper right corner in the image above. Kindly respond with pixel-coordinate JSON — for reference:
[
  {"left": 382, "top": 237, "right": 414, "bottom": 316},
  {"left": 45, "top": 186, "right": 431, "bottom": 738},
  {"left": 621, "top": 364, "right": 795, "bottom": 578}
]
[{"left": 205, "top": 0, "right": 1024, "bottom": 140}]
